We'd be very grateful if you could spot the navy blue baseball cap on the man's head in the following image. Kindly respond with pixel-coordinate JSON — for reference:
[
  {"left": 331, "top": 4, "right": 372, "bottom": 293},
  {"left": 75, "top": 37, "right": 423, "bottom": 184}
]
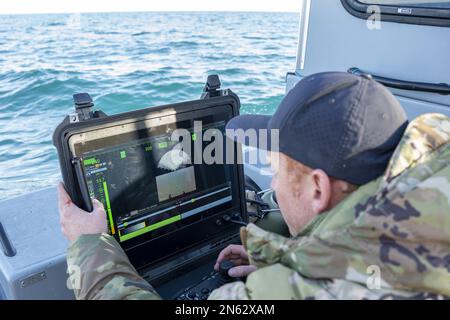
[{"left": 227, "top": 72, "right": 408, "bottom": 185}]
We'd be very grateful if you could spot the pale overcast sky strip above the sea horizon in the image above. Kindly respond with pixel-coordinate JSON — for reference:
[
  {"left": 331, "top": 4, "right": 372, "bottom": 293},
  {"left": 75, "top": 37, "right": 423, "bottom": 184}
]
[{"left": 0, "top": 0, "right": 300, "bottom": 14}]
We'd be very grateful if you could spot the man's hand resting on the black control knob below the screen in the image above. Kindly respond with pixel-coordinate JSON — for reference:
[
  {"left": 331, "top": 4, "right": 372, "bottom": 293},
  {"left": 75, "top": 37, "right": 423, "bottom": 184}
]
[{"left": 214, "top": 244, "right": 256, "bottom": 278}]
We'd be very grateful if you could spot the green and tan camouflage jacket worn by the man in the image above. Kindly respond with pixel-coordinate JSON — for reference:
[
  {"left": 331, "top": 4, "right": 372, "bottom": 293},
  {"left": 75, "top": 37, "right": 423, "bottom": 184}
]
[{"left": 68, "top": 114, "right": 450, "bottom": 299}]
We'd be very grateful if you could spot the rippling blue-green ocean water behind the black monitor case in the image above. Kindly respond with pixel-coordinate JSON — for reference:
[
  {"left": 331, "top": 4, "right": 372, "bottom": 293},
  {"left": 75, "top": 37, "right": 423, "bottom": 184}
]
[{"left": 0, "top": 13, "right": 299, "bottom": 200}]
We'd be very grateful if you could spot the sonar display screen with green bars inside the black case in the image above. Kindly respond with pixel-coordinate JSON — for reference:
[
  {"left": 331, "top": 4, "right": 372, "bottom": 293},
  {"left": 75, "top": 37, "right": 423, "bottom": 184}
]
[{"left": 75, "top": 114, "right": 236, "bottom": 243}]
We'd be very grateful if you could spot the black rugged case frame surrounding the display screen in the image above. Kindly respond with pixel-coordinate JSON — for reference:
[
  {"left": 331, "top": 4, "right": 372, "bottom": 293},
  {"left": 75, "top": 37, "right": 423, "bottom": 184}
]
[{"left": 53, "top": 75, "right": 248, "bottom": 279}]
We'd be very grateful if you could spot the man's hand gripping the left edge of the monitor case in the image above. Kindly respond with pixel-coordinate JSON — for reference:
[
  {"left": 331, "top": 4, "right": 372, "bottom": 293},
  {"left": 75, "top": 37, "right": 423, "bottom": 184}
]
[{"left": 58, "top": 183, "right": 108, "bottom": 242}]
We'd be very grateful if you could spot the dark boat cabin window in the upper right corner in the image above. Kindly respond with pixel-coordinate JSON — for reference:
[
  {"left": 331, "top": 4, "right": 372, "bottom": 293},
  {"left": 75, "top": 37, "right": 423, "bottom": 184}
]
[{"left": 341, "top": 0, "right": 450, "bottom": 27}]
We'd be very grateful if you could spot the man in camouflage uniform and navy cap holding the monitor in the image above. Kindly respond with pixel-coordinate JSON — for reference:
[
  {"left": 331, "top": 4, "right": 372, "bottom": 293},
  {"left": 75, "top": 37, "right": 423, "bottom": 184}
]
[{"left": 59, "top": 74, "right": 450, "bottom": 299}]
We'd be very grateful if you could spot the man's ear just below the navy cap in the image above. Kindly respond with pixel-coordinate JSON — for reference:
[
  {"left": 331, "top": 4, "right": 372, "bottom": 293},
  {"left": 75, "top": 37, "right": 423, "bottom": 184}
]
[{"left": 311, "top": 169, "right": 331, "bottom": 215}]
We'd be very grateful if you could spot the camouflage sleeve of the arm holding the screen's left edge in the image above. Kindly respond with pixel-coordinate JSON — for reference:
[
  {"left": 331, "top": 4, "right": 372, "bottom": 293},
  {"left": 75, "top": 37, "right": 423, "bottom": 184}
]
[{"left": 67, "top": 234, "right": 161, "bottom": 300}]
